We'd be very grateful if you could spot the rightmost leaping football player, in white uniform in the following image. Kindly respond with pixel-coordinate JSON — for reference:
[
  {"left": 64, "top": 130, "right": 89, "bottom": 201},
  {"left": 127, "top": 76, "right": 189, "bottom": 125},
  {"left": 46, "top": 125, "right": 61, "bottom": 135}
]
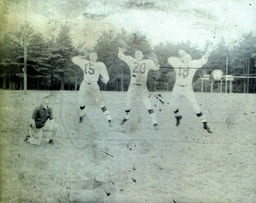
[{"left": 168, "top": 50, "right": 212, "bottom": 133}]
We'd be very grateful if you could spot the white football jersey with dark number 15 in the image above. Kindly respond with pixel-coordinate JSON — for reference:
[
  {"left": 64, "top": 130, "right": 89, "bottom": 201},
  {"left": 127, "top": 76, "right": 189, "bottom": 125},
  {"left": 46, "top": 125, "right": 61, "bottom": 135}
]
[{"left": 72, "top": 56, "right": 109, "bottom": 84}]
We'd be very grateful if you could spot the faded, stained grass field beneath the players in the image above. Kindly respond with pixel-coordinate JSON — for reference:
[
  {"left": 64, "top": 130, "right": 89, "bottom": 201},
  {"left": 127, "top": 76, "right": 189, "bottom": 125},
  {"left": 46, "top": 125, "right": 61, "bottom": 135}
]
[{"left": 0, "top": 91, "right": 256, "bottom": 202}]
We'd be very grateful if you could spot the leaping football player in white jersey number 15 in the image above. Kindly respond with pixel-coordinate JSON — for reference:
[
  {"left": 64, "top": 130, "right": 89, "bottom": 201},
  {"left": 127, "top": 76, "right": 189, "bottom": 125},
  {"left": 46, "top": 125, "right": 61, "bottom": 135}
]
[{"left": 72, "top": 50, "right": 112, "bottom": 126}]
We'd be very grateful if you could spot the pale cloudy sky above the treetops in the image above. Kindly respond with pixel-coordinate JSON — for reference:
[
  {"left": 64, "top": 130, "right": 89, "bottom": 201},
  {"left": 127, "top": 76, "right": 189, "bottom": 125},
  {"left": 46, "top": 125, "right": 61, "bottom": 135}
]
[{"left": 0, "top": 0, "right": 256, "bottom": 47}]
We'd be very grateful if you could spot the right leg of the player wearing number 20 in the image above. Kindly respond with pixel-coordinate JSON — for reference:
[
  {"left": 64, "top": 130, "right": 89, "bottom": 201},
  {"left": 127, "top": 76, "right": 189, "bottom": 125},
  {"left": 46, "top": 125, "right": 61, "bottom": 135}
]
[{"left": 139, "top": 87, "right": 158, "bottom": 129}]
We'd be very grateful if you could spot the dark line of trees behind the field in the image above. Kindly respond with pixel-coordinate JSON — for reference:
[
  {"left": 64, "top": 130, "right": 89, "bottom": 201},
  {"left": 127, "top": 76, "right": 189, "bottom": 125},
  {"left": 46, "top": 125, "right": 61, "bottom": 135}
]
[{"left": 0, "top": 25, "right": 256, "bottom": 92}]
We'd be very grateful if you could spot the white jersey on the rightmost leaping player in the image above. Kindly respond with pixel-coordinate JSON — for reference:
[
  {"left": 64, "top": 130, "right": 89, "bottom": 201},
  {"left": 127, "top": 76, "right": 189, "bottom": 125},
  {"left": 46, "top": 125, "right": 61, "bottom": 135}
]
[{"left": 168, "top": 57, "right": 207, "bottom": 86}]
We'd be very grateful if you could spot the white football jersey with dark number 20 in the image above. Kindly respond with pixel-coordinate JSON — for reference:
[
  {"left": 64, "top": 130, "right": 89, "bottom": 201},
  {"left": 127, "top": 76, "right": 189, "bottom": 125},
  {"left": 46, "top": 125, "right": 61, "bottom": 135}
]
[{"left": 118, "top": 53, "right": 160, "bottom": 85}]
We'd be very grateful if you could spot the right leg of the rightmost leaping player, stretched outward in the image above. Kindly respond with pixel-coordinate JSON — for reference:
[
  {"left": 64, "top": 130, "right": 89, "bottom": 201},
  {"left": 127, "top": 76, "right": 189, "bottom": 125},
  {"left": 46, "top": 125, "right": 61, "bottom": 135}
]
[{"left": 185, "top": 88, "right": 212, "bottom": 133}]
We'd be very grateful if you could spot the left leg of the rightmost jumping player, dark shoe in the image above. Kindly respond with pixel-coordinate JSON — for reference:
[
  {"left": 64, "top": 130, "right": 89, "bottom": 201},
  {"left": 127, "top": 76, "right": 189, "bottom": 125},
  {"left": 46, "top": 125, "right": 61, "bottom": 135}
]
[{"left": 172, "top": 86, "right": 183, "bottom": 126}]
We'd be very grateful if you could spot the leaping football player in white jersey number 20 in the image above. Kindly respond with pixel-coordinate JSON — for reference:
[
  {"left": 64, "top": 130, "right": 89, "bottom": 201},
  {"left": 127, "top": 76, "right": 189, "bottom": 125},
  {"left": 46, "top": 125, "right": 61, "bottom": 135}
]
[{"left": 118, "top": 48, "right": 160, "bottom": 129}]
